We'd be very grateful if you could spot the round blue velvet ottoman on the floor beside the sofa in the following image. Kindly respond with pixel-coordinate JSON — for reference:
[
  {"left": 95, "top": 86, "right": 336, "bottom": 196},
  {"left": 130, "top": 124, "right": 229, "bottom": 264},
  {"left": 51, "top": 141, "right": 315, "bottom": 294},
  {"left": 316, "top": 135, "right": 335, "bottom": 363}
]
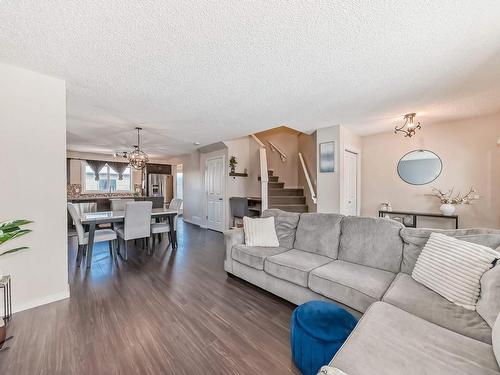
[{"left": 290, "top": 301, "right": 357, "bottom": 375}]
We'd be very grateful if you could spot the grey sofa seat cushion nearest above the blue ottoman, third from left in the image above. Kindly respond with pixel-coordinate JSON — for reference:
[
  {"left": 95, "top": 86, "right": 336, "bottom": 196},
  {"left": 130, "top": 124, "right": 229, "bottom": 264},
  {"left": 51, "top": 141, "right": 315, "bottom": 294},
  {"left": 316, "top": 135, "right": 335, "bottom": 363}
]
[{"left": 309, "top": 260, "right": 395, "bottom": 312}]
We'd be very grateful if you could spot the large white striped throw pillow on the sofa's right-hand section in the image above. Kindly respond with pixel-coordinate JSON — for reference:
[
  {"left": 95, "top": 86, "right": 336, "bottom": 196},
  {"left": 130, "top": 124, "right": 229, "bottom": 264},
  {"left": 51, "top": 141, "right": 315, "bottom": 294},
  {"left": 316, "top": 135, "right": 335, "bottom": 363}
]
[{"left": 411, "top": 233, "right": 500, "bottom": 310}]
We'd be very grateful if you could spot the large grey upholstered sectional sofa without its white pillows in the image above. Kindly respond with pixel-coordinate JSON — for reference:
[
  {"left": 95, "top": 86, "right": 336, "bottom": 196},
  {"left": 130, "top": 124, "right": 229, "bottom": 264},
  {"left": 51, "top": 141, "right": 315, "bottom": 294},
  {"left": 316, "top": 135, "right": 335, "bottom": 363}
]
[{"left": 224, "top": 209, "right": 500, "bottom": 375}]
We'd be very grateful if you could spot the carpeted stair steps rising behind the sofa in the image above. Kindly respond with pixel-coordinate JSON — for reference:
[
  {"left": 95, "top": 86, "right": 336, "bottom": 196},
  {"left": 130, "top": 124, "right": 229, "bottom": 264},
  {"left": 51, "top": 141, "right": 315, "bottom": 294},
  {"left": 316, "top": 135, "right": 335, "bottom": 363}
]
[{"left": 259, "top": 170, "right": 308, "bottom": 212}]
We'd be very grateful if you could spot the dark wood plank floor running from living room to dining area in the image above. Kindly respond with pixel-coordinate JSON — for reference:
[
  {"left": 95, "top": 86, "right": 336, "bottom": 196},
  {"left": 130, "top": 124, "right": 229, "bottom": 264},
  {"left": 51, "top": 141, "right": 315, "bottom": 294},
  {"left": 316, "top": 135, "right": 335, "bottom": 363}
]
[{"left": 0, "top": 222, "right": 299, "bottom": 375}]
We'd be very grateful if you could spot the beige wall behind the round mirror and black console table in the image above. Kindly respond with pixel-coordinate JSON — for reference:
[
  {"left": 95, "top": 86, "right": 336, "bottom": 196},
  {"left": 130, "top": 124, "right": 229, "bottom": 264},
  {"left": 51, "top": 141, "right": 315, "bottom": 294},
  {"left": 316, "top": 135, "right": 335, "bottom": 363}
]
[{"left": 362, "top": 113, "right": 500, "bottom": 228}]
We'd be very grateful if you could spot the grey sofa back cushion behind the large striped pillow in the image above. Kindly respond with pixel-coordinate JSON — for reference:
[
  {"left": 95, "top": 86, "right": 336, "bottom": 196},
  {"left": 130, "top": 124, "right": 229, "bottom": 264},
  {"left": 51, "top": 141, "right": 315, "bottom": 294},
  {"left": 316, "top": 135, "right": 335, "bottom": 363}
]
[{"left": 401, "top": 228, "right": 500, "bottom": 275}]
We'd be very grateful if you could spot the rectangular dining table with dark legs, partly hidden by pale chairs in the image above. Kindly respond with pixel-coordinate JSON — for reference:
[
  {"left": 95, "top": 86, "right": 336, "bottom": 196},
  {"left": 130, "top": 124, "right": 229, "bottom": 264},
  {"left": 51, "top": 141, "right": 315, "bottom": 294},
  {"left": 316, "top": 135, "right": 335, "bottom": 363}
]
[{"left": 80, "top": 208, "right": 179, "bottom": 268}]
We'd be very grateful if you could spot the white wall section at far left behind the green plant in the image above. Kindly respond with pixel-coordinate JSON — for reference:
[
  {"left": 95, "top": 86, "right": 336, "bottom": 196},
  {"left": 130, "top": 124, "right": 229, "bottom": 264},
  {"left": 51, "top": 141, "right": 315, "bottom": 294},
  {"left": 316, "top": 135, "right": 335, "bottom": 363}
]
[{"left": 0, "top": 64, "right": 69, "bottom": 311}]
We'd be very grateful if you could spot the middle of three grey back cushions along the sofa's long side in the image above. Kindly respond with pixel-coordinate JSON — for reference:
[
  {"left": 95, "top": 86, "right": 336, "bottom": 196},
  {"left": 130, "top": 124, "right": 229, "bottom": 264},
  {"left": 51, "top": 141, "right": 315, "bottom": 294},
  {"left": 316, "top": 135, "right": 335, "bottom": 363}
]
[{"left": 293, "top": 213, "right": 344, "bottom": 259}]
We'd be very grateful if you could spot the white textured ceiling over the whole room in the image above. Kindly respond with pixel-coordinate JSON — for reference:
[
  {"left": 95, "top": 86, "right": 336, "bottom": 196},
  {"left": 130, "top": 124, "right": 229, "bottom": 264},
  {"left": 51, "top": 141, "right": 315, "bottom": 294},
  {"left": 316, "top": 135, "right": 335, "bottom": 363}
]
[{"left": 0, "top": 0, "right": 500, "bottom": 156}]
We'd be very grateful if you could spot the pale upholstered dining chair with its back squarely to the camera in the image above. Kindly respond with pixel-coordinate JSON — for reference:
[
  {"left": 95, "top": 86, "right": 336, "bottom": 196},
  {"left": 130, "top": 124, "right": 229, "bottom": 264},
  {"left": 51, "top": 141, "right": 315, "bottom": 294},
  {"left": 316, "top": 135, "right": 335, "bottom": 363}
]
[{"left": 116, "top": 202, "right": 153, "bottom": 260}]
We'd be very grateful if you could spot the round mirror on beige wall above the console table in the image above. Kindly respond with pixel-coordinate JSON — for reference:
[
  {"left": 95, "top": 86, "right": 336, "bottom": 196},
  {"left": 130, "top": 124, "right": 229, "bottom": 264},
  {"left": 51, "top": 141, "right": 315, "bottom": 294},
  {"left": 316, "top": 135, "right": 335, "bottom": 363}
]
[{"left": 398, "top": 150, "right": 443, "bottom": 185}]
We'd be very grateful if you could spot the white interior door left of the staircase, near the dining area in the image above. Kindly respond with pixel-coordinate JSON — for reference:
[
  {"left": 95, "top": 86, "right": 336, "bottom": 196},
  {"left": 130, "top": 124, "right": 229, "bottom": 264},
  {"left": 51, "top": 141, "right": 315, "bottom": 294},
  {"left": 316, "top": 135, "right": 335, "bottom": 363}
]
[{"left": 206, "top": 156, "right": 224, "bottom": 231}]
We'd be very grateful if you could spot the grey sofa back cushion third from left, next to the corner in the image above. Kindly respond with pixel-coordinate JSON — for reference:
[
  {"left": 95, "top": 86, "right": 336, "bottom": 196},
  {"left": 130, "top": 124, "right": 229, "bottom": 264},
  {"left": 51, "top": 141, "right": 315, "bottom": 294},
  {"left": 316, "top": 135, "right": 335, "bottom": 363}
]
[{"left": 338, "top": 216, "right": 403, "bottom": 273}]
